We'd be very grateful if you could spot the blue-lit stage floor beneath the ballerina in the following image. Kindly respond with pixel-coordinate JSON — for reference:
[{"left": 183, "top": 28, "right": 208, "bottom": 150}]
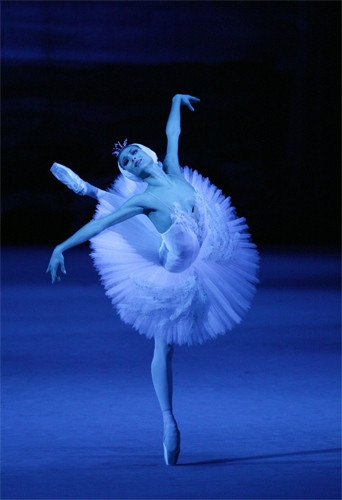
[{"left": 1, "top": 247, "right": 341, "bottom": 499}]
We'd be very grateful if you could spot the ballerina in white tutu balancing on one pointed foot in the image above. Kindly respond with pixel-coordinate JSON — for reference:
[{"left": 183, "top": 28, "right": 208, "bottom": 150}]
[{"left": 47, "top": 94, "right": 259, "bottom": 465}]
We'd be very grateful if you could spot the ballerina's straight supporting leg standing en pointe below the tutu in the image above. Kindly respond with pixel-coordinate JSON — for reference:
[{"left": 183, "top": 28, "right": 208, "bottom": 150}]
[{"left": 151, "top": 339, "right": 180, "bottom": 465}]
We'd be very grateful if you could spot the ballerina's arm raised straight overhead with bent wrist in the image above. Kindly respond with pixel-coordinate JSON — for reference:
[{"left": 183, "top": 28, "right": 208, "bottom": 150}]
[{"left": 164, "top": 94, "right": 199, "bottom": 174}]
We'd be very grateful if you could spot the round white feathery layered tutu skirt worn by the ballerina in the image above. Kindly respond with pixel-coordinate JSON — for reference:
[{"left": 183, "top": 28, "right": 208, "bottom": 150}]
[{"left": 90, "top": 167, "right": 259, "bottom": 345}]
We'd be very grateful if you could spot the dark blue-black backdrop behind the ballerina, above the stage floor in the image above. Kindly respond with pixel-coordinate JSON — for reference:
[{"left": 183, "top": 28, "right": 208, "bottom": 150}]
[{"left": 1, "top": 1, "right": 341, "bottom": 245}]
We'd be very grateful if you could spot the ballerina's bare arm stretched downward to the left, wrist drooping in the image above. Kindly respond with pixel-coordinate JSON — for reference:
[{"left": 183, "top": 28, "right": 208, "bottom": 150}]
[{"left": 46, "top": 195, "right": 145, "bottom": 283}]
